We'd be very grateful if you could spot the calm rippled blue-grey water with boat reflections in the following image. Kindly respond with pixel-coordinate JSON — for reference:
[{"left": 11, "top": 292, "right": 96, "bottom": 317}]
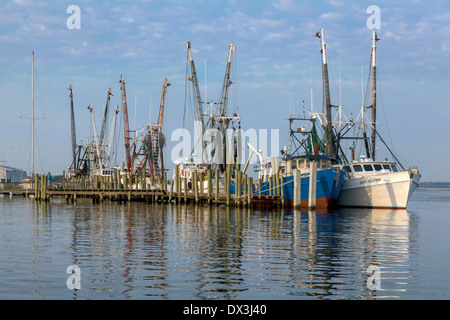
[{"left": 0, "top": 190, "right": 450, "bottom": 300}]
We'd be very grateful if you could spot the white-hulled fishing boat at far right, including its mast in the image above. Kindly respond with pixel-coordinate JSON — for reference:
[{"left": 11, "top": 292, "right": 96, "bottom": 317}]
[{"left": 335, "top": 31, "right": 421, "bottom": 209}]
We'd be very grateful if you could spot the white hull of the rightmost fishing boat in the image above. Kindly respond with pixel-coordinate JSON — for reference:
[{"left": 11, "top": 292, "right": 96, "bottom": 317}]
[{"left": 337, "top": 170, "right": 421, "bottom": 209}]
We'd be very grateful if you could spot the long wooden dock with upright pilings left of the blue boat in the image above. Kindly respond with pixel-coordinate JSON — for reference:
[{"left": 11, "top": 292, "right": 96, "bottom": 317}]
[{"left": 0, "top": 171, "right": 284, "bottom": 208}]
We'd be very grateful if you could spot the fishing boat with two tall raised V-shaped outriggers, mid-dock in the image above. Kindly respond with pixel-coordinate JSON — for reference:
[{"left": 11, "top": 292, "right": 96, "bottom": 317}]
[{"left": 173, "top": 41, "right": 241, "bottom": 191}]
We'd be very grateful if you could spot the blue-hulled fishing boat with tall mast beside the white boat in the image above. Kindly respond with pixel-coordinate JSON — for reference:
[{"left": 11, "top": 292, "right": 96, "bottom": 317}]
[{"left": 246, "top": 30, "right": 345, "bottom": 209}]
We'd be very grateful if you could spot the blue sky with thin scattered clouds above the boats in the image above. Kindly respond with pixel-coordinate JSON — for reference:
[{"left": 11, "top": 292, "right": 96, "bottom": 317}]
[{"left": 0, "top": 0, "right": 450, "bottom": 181}]
